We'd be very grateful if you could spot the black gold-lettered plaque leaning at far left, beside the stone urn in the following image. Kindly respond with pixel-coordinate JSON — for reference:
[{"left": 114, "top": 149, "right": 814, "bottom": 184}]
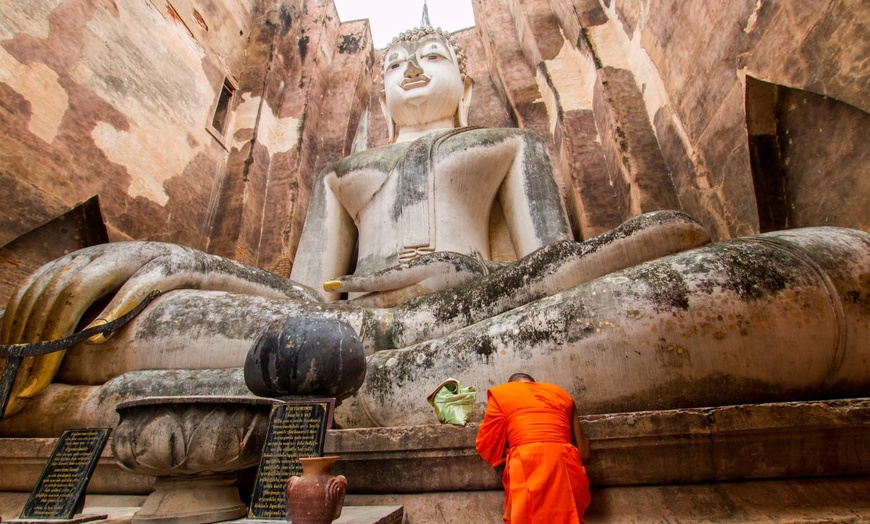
[{"left": 19, "top": 428, "right": 110, "bottom": 520}]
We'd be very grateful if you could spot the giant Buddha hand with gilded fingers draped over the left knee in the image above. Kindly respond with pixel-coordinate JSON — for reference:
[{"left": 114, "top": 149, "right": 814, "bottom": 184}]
[{"left": 0, "top": 242, "right": 316, "bottom": 413}]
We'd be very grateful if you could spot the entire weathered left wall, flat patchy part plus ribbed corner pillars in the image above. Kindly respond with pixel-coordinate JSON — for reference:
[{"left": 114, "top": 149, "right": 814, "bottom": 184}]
[{"left": 0, "top": 0, "right": 373, "bottom": 286}]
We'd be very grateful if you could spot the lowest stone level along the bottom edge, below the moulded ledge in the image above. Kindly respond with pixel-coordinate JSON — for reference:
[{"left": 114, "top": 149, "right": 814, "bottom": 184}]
[{"left": 0, "top": 477, "right": 870, "bottom": 524}]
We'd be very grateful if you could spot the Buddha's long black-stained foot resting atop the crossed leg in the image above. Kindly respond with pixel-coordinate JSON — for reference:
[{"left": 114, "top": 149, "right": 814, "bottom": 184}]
[{"left": 373, "top": 211, "right": 710, "bottom": 349}]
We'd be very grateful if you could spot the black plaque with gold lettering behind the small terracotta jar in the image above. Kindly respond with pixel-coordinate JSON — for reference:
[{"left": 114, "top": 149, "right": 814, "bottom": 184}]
[{"left": 248, "top": 399, "right": 335, "bottom": 521}]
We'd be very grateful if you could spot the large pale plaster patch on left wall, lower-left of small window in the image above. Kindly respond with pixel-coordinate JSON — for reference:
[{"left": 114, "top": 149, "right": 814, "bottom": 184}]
[{"left": 91, "top": 122, "right": 197, "bottom": 206}]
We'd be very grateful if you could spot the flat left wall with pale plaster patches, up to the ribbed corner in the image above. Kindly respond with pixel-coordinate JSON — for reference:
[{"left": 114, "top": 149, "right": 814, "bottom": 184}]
[{"left": 0, "top": 0, "right": 253, "bottom": 248}]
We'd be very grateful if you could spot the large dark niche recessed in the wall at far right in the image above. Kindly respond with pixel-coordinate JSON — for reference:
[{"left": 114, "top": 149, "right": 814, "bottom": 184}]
[{"left": 746, "top": 76, "right": 870, "bottom": 232}]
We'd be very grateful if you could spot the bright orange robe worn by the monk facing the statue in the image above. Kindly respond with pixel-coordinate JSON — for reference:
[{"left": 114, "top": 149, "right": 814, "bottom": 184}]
[{"left": 476, "top": 382, "right": 590, "bottom": 524}]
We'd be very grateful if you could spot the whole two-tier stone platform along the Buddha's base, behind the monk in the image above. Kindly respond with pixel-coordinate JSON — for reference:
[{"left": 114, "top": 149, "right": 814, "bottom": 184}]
[{"left": 0, "top": 398, "right": 870, "bottom": 524}]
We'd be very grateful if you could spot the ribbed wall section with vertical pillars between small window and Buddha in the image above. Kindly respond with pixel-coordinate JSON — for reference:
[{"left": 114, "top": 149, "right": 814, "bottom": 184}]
[{"left": 208, "top": 0, "right": 374, "bottom": 274}]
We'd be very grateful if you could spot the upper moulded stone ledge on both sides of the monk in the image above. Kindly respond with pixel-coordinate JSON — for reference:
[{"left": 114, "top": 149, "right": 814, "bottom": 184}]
[{"left": 325, "top": 399, "right": 870, "bottom": 493}]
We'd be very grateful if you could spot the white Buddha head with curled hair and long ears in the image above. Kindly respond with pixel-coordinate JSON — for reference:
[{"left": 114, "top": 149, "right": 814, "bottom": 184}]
[{"left": 381, "top": 27, "right": 473, "bottom": 142}]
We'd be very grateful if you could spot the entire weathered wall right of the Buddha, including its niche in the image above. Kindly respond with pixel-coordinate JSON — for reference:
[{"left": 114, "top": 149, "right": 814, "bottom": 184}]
[{"left": 474, "top": 0, "right": 870, "bottom": 238}]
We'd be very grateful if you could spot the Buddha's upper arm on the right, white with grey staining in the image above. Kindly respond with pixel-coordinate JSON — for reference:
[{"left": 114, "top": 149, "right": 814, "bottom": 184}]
[{"left": 498, "top": 131, "right": 572, "bottom": 257}]
